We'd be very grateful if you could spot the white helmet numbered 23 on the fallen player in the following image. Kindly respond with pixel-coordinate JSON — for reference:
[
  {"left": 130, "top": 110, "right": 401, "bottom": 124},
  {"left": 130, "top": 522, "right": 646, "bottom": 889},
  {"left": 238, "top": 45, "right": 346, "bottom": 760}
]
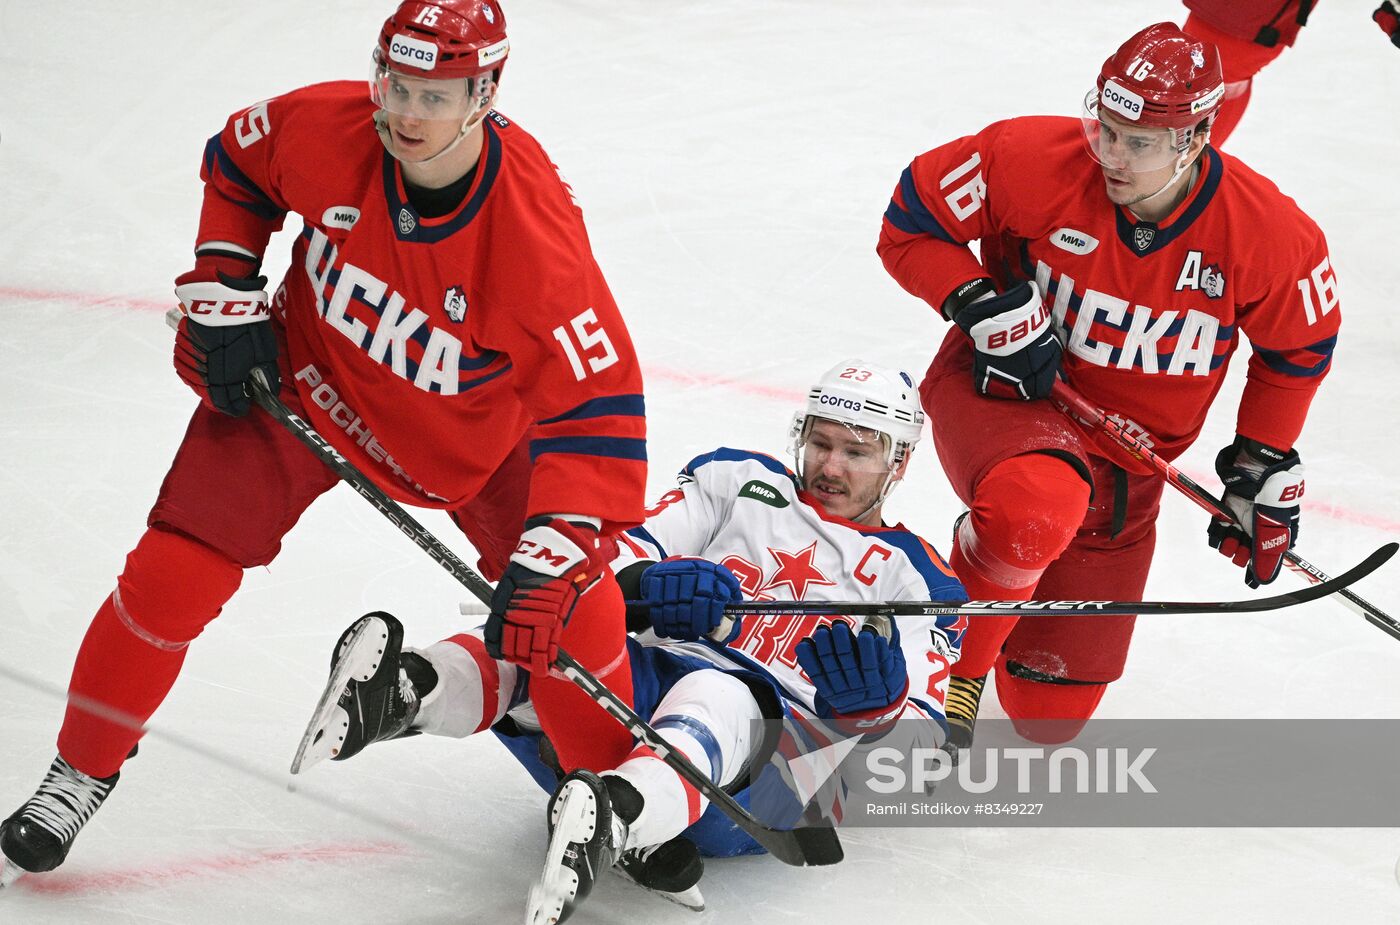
[{"left": 788, "top": 360, "right": 924, "bottom": 504}]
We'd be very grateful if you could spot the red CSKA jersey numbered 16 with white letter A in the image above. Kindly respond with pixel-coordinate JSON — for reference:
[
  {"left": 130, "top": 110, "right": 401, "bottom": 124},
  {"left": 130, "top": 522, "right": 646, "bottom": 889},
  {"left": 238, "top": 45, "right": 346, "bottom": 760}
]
[{"left": 878, "top": 116, "right": 1341, "bottom": 458}]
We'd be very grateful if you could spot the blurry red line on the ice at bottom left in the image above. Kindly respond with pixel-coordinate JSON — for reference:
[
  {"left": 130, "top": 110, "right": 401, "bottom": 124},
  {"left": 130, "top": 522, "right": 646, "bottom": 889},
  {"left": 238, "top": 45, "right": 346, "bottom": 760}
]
[{"left": 14, "top": 842, "right": 407, "bottom": 896}]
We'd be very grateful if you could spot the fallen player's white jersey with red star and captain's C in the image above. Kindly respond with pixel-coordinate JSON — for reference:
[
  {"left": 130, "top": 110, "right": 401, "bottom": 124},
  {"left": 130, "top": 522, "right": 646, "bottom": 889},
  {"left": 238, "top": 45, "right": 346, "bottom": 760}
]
[{"left": 613, "top": 448, "right": 967, "bottom": 726}]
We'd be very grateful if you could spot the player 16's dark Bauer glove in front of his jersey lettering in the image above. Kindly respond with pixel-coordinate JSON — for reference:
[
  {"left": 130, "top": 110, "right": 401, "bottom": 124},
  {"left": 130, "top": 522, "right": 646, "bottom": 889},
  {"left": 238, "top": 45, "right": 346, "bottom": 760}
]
[{"left": 949, "top": 280, "right": 1063, "bottom": 402}]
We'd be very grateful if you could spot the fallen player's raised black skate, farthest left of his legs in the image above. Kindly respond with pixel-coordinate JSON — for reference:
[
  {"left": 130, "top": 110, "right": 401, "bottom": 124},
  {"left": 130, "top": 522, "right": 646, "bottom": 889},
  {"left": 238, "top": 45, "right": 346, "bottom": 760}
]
[{"left": 291, "top": 612, "right": 437, "bottom": 774}]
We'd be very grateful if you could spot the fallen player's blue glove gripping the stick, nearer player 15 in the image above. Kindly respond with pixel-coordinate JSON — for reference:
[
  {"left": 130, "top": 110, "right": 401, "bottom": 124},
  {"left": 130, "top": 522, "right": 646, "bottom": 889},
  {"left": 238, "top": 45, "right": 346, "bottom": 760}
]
[{"left": 641, "top": 558, "right": 742, "bottom": 642}]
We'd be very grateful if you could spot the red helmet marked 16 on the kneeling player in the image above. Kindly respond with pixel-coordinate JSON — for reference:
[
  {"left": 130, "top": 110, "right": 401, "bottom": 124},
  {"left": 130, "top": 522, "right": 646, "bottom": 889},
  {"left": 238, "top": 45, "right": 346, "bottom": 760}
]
[{"left": 1096, "top": 22, "right": 1225, "bottom": 129}]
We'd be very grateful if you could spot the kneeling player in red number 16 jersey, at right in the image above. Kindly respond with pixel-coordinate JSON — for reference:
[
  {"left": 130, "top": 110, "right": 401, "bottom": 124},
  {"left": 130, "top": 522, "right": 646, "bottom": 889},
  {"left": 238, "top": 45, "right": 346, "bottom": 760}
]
[{"left": 878, "top": 22, "right": 1341, "bottom": 743}]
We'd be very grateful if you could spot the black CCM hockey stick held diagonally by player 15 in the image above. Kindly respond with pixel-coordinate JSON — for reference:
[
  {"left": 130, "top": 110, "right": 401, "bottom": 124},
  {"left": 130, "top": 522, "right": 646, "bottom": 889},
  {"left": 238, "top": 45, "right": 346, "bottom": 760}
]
[{"left": 252, "top": 371, "right": 843, "bottom": 868}]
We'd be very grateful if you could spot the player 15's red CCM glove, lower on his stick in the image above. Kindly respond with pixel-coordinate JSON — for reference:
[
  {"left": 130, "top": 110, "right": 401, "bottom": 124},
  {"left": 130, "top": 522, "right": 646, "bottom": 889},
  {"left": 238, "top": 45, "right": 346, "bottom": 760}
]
[{"left": 486, "top": 515, "right": 606, "bottom": 675}]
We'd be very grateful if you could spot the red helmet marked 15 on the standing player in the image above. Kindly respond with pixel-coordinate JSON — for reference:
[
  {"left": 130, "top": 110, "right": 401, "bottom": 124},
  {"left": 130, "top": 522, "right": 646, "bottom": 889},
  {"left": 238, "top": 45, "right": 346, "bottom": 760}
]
[{"left": 374, "top": 0, "right": 511, "bottom": 83}]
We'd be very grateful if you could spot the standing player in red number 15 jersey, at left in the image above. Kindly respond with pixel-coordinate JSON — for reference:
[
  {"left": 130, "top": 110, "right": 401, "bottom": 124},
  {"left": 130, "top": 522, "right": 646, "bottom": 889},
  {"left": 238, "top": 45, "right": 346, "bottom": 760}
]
[{"left": 0, "top": 0, "right": 645, "bottom": 880}]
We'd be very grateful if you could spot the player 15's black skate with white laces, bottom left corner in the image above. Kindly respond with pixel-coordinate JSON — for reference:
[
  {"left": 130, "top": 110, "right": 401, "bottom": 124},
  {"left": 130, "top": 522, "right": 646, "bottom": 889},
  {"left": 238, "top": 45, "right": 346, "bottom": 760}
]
[{"left": 0, "top": 756, "right": 120, "bottom": 887}]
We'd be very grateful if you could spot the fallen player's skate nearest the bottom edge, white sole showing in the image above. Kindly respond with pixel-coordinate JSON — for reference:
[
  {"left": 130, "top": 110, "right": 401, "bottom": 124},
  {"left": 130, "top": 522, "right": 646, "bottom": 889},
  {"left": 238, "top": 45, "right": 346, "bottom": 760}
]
[{"left": 525, "top": 771, "right": 643, "bottom": 925}]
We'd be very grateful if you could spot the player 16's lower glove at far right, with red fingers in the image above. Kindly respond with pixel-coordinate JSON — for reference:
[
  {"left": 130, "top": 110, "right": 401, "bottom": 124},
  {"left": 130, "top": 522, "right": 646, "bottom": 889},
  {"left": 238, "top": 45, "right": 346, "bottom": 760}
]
[{"left": 1207, "top": 437, "right": 1303, "bottom": 588}]
